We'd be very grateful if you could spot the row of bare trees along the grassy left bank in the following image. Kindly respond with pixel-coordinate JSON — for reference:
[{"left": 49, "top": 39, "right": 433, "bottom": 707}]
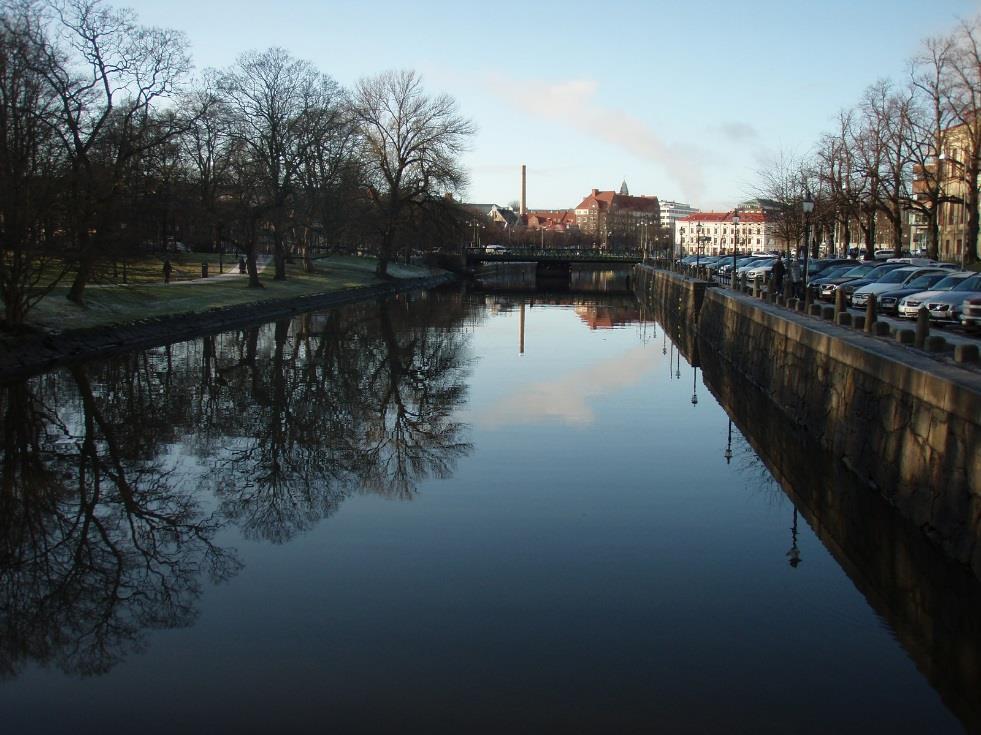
[{"left": 0, "top": 0, "right": 473, "bottom": 326}]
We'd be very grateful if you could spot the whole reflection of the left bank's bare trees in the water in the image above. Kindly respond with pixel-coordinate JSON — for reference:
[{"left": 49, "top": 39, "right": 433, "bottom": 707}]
[{"left": 0, "top": 295, "right": 470, "bottom": 677}]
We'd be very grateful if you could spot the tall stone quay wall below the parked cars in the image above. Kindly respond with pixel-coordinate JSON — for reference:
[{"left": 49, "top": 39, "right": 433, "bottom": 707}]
[{"left": 636, "top": 266, "right": 981, "bottom": 577}]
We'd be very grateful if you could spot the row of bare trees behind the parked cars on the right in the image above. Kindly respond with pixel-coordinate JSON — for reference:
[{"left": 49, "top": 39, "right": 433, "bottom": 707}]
[{"left": 759, "top": 16, "right": 981, "bottom": 264}]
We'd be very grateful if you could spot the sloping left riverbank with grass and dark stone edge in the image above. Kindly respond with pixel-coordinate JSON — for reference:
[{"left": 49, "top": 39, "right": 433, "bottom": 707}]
[{"left": 0, "top": 258, "right": 457, "bottom": 382}]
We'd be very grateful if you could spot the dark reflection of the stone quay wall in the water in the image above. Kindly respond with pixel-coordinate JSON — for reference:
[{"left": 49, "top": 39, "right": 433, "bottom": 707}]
[{"left": 655, "top": 294, "right": 981, "bottom": 732}]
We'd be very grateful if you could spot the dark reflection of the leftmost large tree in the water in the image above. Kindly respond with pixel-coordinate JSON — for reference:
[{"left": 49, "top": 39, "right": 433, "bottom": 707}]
[{"left": 0, "top": 367, "right": 238, "bottom": 676}]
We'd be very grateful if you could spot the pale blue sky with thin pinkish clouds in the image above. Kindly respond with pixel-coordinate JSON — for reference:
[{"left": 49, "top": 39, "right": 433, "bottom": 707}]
[{"left": 120, "top": 0, "right": 981, "bottom": 209}]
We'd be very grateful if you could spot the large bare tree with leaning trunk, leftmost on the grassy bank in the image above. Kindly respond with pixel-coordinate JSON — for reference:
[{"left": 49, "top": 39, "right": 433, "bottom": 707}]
[{"left": 23, "top": 0, "right": 190, "bottom": 303}]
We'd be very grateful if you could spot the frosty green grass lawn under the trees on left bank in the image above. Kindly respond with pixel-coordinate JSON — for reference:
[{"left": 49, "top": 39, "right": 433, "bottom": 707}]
[{"left": 28, "top": 254, "right": 431, "bottom": 331}]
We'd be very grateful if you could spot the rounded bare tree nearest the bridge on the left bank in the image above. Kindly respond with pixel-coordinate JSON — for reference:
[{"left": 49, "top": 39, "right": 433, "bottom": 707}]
[{"left": 353, "top": 70, "right": 474, "bottom": 277}]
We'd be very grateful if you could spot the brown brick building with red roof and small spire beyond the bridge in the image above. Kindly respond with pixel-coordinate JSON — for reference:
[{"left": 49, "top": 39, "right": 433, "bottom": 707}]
[{"left": 575, "top": 181, "right": 661, "bottom": 249}]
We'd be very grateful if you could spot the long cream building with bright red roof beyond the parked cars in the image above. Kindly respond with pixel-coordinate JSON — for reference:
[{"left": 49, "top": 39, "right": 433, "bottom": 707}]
[{"left": 674, "top": 210, "right": 778, "bottom": 255}]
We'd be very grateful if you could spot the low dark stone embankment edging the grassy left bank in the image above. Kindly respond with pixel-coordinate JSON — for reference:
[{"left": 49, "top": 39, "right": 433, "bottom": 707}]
[{"left": 0, "top": 273, "right": 457, "bottom": 382}]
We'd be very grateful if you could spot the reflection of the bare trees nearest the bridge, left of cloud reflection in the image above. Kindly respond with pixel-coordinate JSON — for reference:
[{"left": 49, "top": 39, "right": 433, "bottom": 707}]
[{"left": 208, "top": 299, "right": 470, "bottom": 543}]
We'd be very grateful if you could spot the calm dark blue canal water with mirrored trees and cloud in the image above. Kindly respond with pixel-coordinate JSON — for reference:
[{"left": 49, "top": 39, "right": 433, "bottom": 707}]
[{"left": 0, "top": 274, "right": 981, "bottom": 733}]
